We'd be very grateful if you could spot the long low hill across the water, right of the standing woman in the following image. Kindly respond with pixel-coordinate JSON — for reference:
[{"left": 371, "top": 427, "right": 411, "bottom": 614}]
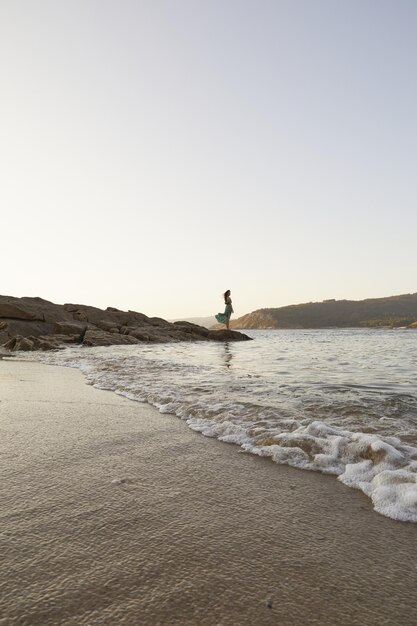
[{"left": 230, "top": 293, "right": 417, "bottom": 329}]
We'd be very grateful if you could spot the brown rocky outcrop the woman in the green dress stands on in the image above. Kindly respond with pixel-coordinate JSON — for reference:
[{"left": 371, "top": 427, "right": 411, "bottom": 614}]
[{"left": 0, "top": 296, "right": 250, "bottom": 351}]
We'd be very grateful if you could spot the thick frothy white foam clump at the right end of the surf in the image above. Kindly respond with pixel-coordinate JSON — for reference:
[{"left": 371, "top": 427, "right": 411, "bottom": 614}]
[{"left": 242, "top": 421, "right": 417, "bottom": 522}]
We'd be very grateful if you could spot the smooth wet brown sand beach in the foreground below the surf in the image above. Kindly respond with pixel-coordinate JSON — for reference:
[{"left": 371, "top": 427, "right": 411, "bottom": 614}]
[{"left": 0, "top": 360, "right": 417, "bottom": 626}]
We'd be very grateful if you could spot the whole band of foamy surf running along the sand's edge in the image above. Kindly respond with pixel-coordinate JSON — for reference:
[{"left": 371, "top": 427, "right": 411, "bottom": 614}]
[{"left": 18, "top": 351, "right": 417, "bottom": 522}]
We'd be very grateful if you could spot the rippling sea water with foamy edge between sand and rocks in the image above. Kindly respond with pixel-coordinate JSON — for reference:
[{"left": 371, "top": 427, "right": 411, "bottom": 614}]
[{"left": 21, "top": 329, "right": 417, "bottom": 522}]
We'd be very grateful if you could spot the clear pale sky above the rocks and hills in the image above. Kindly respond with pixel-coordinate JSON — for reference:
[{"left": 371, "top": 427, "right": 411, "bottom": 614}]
[{"left": 0, "top": 0, "right": 417, "bottom": 318}]
